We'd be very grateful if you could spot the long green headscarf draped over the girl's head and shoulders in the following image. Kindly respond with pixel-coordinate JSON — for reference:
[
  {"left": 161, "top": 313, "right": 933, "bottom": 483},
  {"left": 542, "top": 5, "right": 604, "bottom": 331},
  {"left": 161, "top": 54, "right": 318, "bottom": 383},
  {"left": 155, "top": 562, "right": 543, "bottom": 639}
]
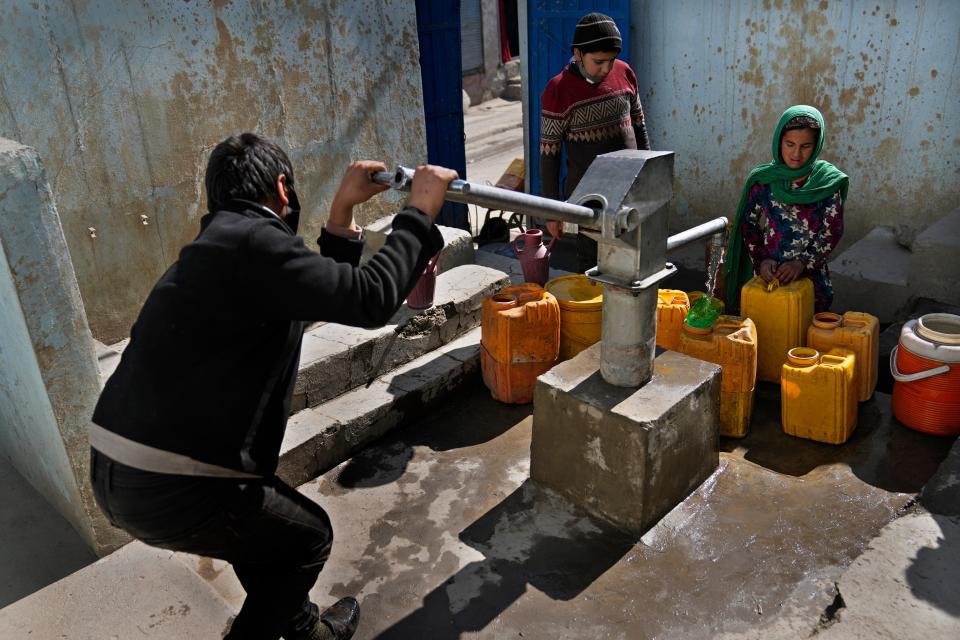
[{"left": 723, "top": 104, "right": 849, "bottom": 309}]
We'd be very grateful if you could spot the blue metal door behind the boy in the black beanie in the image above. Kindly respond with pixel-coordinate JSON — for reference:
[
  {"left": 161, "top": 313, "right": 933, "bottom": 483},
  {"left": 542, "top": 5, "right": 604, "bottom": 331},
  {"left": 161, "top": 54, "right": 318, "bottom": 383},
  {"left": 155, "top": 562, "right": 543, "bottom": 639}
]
[{"left": 521, "top": 0, "right": 630, "bottom": 195}]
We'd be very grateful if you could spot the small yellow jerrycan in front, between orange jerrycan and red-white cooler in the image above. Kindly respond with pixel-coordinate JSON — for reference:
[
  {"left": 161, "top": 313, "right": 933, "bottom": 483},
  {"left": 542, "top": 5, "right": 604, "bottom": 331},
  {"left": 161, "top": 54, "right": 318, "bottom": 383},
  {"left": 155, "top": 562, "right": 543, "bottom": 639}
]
[{"left": 780, "top": 347, "right": 857, "bottom": 444}]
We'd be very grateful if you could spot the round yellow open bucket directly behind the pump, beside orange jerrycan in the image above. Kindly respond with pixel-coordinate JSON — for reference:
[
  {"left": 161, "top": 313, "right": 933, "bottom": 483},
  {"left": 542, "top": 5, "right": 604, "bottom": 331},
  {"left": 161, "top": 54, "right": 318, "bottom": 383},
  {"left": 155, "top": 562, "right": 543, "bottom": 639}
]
[{"left": 544, "top": 274, "right": 603, "bottom": 360}]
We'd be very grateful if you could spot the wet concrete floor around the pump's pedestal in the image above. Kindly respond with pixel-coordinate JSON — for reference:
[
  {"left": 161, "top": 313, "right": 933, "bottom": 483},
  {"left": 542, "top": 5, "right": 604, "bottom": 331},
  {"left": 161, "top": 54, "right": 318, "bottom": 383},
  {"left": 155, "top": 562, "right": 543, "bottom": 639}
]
[{"left": 290, "top": 372, "right": 954, "bottom": 640}]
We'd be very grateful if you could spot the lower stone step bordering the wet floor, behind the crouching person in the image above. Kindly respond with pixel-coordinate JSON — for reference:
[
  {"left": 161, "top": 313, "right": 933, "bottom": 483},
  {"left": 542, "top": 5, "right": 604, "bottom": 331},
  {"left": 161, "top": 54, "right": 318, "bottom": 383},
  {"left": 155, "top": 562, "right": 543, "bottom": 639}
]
[{"left": 277, "top": 327, "right": 488, "bottom": 486}]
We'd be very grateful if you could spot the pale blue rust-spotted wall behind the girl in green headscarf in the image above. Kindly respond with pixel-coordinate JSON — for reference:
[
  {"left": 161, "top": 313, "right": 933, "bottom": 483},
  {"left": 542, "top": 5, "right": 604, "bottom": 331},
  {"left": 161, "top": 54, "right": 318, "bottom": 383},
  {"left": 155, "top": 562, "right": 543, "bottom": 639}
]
[{"left": 631, "top": 0, "right": 960, "bottom": 249}]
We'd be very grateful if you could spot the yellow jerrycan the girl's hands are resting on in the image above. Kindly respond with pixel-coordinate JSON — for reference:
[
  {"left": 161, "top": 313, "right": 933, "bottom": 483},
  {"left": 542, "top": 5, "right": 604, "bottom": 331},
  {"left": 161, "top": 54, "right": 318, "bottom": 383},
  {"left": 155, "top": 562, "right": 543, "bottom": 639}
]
[{"left": 740, "top": 276, "right": 813, "bottom": 382}]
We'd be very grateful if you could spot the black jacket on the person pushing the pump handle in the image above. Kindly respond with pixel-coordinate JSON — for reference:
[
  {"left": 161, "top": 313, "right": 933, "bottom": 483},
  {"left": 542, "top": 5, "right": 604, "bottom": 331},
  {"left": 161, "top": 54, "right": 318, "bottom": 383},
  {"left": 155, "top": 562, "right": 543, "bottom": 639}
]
[{"left": 93, "top": 200, "right": 443, "bottom": 476}]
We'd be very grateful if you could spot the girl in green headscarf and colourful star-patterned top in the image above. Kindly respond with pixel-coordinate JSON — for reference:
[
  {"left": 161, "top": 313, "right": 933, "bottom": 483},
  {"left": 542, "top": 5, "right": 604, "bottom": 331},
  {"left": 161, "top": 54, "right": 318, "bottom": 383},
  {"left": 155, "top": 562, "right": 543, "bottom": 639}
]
[{"left": 723, "top": 104, "right": 848, "bottom": 311}]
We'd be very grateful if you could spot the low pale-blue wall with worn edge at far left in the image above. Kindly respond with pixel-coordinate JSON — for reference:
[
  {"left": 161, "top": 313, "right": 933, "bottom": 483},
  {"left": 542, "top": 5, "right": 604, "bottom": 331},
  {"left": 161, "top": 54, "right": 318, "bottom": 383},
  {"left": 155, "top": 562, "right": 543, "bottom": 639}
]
[{"left": 0, "top": 138, "right": 123, "bottom": 553}]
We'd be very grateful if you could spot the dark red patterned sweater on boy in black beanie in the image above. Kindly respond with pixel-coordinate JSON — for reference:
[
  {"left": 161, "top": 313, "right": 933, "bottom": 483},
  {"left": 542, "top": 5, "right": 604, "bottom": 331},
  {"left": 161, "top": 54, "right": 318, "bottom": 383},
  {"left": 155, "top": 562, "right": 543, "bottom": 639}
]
[{"left": 540, "top": 60, "right": 650, "bottom": 200}]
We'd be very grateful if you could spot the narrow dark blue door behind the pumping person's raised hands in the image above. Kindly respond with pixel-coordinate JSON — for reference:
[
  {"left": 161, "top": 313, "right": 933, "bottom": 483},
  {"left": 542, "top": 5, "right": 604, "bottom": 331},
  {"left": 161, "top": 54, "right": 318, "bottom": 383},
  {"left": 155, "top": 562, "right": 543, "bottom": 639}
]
[{"left": 417, "top": 0, "right": 468, "bottom": 229}]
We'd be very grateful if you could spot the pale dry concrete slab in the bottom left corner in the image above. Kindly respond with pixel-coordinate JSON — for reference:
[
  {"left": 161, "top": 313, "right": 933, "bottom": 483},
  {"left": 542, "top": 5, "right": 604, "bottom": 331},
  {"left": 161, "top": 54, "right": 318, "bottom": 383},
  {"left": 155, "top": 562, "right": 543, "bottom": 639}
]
[{"left": 0, "top": 542, "right": 235, "bottom": 640}]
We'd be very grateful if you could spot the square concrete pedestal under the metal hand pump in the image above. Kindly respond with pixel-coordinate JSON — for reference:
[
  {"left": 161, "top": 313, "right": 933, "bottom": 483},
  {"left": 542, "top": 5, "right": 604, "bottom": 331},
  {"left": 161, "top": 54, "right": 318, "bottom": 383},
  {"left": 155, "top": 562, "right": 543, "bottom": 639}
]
[{"left": 530, "top": 343, "right": 720, "bottom": 536}]
